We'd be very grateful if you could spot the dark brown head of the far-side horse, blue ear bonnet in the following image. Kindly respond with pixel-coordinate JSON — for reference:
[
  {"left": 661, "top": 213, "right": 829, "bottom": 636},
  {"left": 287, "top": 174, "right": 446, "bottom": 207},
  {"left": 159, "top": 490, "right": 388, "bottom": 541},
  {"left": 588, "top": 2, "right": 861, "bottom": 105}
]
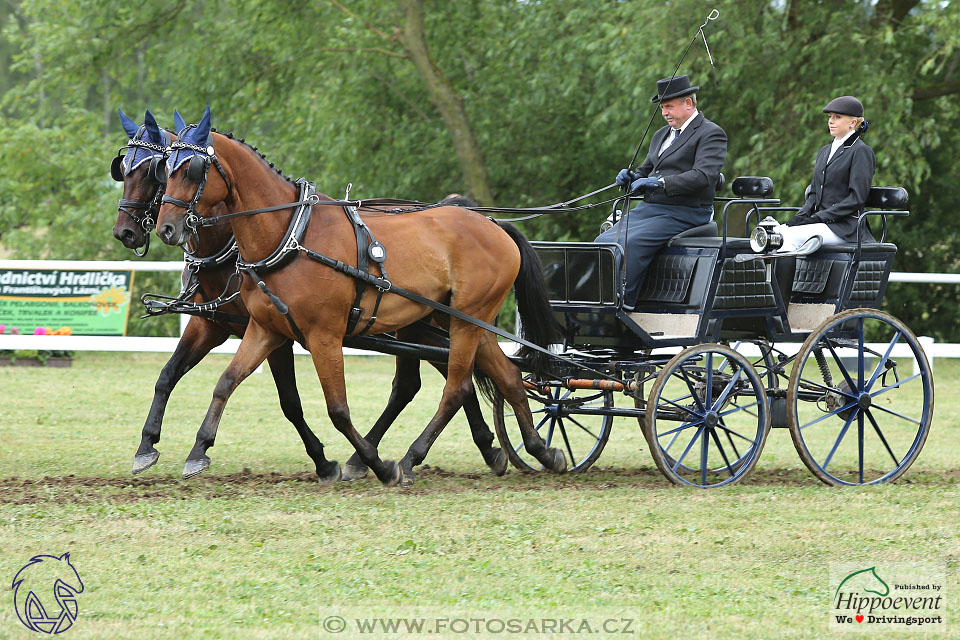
[{"left": 110, "top": 109, "right": 173, "bottom": 256}]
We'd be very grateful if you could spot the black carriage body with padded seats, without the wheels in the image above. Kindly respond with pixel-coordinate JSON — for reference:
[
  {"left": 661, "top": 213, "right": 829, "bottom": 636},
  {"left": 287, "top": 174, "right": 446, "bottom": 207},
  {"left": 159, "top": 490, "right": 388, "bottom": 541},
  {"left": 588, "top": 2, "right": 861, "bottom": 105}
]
[{"left": 533, "top": 237, "right": 897, "bottom": 351}]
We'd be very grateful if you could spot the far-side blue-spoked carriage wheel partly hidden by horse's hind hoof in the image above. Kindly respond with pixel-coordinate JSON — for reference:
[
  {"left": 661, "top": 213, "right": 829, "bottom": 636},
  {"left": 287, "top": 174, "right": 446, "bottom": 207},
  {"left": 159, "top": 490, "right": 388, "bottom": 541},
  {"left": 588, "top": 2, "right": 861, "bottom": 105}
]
[{"left": 493, "top": 387, "right": 613, "bottom": 473}]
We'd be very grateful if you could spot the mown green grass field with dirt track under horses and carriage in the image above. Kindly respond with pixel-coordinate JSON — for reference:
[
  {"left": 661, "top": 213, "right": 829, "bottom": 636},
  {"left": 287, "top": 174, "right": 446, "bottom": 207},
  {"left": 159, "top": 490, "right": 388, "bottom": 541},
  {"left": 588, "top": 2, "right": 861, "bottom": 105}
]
[{"left": 0, "top": 353, "right": 960, "bottom": 638}]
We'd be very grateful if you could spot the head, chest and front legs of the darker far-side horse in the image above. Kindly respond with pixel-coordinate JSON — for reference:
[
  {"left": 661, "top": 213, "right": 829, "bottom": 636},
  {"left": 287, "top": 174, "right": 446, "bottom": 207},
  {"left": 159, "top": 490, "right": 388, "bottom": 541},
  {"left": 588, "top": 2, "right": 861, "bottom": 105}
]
[{"left": 111, "top": 110, "right": 340, "bottom": 485}]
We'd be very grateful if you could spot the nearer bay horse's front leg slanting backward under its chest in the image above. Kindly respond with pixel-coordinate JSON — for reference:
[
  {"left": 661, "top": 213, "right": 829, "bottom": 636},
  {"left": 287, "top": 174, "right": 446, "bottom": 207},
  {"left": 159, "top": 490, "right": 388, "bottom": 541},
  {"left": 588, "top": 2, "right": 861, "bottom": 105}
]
[{"left": 307, "top": 336, "right": 400, "bottom": 487}]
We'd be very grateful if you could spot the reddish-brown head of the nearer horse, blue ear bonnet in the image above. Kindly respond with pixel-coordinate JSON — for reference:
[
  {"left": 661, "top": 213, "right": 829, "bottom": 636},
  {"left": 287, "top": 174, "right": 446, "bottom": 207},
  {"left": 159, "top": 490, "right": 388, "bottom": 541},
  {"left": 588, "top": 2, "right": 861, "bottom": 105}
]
[{"left": 157, "top": 106, "right": 231, "bottom": 247}]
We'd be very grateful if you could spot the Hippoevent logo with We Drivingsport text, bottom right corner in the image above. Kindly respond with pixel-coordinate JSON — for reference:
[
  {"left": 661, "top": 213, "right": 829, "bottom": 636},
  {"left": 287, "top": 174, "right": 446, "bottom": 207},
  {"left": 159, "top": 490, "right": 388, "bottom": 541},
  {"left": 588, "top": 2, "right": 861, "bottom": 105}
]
[{"left": 830, "top": 563, "right": 947, "bottom": 633}]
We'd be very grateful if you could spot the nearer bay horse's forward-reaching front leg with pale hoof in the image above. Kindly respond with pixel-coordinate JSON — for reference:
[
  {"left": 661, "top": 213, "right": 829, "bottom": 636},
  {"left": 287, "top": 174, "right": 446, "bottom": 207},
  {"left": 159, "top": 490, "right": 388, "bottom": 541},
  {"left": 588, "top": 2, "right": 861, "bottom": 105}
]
[{"left": 183, "top": 319, "right": 286, "bottom": 479}]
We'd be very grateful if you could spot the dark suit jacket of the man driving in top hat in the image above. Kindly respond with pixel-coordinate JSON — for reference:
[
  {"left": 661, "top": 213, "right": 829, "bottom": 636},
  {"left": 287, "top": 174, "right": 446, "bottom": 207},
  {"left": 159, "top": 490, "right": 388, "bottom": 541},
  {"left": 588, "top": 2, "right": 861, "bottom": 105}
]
[{"left": 637, "top": 113, "right": 727, "bottom": 207}]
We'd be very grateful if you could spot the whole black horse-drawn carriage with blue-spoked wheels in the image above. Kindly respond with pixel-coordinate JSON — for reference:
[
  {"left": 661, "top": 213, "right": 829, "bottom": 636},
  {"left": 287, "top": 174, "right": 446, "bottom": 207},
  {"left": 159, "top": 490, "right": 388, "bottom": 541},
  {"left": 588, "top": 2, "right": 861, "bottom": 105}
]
[{"left": 494, "top": 177, "right": 933, "bottom": 488}]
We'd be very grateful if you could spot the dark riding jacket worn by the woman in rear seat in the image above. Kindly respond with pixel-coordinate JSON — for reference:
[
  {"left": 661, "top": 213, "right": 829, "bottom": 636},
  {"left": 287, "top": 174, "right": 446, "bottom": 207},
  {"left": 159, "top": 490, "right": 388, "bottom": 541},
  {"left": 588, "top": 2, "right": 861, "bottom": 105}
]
[{"left": 798, "top": 134, "right": 877, "bottom": 242}]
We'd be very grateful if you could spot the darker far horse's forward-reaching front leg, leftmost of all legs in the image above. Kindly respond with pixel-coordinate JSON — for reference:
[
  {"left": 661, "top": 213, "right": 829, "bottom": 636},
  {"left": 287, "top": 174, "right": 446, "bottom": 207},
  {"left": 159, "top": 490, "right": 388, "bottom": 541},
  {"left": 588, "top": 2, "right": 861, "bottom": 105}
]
[{"left": 133, "top": 316, "right": 230, "bottom": 475}]
